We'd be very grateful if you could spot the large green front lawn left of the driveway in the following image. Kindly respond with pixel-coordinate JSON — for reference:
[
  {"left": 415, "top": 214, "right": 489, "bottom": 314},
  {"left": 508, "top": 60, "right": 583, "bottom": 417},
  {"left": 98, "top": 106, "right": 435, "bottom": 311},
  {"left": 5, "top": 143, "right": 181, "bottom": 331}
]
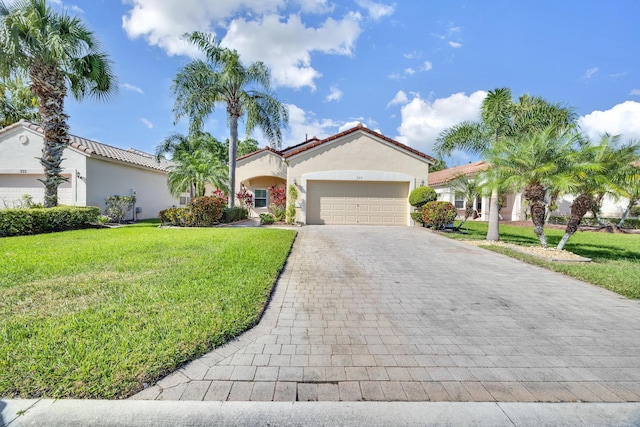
[{"left": 0, "top": 223, "right": 295, "bottom": 398}]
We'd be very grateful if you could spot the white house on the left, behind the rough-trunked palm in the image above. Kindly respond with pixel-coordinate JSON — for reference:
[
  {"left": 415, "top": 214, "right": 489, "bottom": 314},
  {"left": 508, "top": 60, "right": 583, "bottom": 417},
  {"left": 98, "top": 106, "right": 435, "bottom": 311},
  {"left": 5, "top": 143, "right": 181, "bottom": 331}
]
[{"left": 0, "top": 121, "right": 179, "bottom": 219}]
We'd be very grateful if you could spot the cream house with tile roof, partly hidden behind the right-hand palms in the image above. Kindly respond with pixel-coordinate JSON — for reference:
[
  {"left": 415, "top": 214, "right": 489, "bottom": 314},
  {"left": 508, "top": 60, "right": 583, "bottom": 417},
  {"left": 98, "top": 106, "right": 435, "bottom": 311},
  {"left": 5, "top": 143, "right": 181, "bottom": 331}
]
[{"left": 429, "top": 161, "right": 628, "bottom": 221}]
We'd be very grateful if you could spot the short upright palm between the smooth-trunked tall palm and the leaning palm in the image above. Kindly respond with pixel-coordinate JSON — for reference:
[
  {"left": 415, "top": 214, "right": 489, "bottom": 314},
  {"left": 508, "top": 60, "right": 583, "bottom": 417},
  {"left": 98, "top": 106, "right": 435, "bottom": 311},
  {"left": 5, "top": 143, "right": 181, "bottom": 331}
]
[{"left": 486, "top": 126, "right": 577, "bottom": 248}]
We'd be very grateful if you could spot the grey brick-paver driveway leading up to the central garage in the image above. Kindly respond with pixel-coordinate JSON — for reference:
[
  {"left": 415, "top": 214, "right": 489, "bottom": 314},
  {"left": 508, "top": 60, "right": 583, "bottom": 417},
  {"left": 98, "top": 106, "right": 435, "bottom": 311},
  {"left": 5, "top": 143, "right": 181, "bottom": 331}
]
[{"left": 134, "top": 226, "right": 640, "bottom": 401}]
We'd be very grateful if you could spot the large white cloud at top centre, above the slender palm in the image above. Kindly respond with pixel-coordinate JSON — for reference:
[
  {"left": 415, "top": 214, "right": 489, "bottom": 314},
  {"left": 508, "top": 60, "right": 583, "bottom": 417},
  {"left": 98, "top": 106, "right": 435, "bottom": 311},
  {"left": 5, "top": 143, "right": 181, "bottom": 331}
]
[{"left": 122, "top": 0, "right": 362, "bottom": 89}]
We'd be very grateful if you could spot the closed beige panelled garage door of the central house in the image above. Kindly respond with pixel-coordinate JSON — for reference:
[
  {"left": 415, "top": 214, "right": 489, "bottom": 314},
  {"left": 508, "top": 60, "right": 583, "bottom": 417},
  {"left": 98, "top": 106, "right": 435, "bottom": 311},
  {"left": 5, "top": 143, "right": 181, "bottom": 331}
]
[{"left": 307, "top": 181, "right": 409, "bottom": 225}]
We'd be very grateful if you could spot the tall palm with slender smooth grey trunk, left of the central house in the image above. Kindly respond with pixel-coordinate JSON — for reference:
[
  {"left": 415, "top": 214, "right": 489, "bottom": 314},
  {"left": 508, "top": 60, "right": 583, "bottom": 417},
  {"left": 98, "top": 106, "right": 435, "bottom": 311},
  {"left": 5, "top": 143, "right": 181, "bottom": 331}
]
[{"left": 172, "top": 31, "right": 289, "bottom": 207}]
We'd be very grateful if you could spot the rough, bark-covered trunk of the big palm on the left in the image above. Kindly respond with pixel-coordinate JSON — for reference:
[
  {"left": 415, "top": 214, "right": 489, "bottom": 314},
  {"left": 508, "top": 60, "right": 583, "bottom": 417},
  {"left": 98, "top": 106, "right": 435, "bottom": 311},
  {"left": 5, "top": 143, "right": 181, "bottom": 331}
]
[{"left": 30, "top": 64, "right": 69, "bottom": 208}]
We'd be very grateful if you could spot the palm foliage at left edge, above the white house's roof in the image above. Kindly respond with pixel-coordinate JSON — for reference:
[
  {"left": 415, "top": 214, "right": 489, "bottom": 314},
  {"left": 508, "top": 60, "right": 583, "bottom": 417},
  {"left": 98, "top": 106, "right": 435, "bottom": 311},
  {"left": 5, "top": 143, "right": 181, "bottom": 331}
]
[{"left": 0, "top": 73, "right": 38, "bottom": 128}]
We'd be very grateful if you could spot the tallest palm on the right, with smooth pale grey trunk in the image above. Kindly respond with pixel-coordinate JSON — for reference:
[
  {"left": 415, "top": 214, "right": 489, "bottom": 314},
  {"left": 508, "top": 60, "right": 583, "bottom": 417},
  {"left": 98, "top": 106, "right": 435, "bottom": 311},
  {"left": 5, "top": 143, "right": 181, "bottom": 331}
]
[{"left": 436, "top": 87, "right": 575, "bottom": 241}]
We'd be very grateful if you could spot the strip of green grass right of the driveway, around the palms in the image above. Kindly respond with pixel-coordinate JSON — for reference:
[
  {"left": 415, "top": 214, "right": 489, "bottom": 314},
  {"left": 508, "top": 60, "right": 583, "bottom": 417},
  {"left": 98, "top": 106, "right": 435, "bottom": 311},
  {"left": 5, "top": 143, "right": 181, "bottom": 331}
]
[{"left": 446, "top": 222, "right": 640, "bottom": 299}]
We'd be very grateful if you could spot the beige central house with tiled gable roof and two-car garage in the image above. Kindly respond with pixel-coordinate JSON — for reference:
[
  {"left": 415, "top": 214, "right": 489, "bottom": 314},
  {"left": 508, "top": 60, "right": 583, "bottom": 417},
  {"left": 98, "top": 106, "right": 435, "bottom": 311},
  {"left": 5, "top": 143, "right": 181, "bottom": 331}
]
[{"left": 236, "top": 125, "right": 434, "bottom": 225}]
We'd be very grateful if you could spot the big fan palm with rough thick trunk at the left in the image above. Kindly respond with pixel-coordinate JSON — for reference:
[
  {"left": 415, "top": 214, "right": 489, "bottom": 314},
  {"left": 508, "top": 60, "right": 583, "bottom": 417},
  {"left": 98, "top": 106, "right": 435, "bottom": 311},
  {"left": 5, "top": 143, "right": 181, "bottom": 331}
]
[{"left": 0, "top": 0, "right": 117, "bottom": 207}]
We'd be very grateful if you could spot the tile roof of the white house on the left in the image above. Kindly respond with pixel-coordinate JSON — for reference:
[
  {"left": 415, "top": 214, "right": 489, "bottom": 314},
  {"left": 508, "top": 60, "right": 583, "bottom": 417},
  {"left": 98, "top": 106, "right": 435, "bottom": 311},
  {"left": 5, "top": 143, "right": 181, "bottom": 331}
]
[{"left": 5, "top": 120, "right": 175, "bottom": 171}]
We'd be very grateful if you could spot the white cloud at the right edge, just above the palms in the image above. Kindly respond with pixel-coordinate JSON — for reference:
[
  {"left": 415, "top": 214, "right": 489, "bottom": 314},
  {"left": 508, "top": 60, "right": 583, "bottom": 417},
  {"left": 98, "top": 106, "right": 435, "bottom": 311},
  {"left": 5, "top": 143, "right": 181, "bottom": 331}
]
[{"left": 578, "top": 101, "right": 640, "bottom": 141}]
